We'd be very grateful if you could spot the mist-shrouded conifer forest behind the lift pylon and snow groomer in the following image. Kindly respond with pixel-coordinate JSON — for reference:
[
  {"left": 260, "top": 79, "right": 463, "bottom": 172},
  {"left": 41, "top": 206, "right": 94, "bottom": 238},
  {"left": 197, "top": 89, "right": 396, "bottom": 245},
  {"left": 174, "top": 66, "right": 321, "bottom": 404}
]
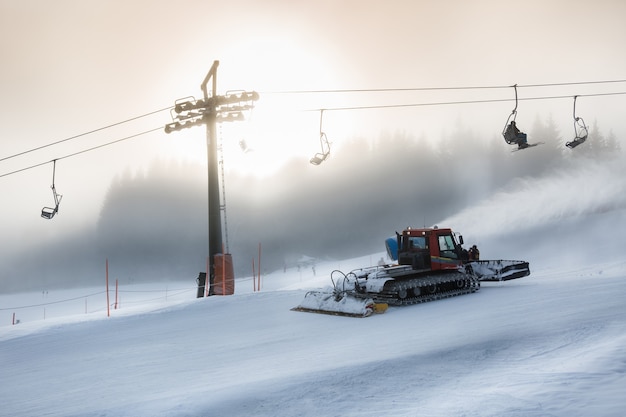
[{"left": 3, "top": 118, "right": 621, "bottom": 285}]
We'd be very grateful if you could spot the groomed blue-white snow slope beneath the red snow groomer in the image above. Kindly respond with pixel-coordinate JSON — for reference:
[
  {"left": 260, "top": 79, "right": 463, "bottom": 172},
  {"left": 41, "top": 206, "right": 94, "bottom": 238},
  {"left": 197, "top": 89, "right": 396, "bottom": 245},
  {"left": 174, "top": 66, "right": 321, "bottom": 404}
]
[{"left": 0, "top": 161, "right": 626, "bottom": 417}]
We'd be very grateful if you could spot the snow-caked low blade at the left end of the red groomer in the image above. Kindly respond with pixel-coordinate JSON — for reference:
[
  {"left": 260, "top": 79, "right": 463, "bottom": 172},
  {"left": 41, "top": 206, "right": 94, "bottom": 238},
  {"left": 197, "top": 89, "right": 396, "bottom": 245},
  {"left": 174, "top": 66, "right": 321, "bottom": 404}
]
[{"left": 291, "top": 291, "right": 387, "bottom": 317}]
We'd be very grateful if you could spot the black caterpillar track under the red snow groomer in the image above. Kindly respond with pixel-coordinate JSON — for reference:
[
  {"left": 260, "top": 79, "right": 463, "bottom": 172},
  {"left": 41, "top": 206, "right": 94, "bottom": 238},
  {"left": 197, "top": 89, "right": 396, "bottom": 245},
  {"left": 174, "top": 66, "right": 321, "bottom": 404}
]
[{"left": 362, "top": 272, "right": 480, "bottom": 306}]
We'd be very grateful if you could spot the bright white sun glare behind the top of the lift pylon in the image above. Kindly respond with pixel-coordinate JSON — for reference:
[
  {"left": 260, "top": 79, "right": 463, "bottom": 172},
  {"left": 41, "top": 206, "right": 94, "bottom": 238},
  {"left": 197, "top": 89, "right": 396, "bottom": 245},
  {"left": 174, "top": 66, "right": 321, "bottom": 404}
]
[{"left": 161, "top": 36, "right": 349, "bottom": 177}]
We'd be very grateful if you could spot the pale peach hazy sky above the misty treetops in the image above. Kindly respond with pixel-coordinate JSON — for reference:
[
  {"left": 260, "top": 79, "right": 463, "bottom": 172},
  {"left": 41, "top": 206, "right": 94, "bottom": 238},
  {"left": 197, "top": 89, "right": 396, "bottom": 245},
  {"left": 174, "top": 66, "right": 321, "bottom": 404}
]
[{"left": 0, "top": 0, "right": 626, "bottom": 256}]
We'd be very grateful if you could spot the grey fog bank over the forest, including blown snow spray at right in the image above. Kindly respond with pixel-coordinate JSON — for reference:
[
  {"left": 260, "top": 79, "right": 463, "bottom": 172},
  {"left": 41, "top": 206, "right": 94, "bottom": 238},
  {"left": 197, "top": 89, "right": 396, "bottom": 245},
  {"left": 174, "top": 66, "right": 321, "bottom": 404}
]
[{"left": 0, "top": 118, "right": 626, "bottom": 291}]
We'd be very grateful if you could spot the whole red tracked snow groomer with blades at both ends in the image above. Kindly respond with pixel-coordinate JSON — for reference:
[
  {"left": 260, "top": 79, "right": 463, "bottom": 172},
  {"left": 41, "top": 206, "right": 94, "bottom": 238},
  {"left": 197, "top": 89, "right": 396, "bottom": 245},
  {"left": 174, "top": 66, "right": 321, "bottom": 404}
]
[{"left": 293, "top": 227, "right": 530, "bottom": 317}]
